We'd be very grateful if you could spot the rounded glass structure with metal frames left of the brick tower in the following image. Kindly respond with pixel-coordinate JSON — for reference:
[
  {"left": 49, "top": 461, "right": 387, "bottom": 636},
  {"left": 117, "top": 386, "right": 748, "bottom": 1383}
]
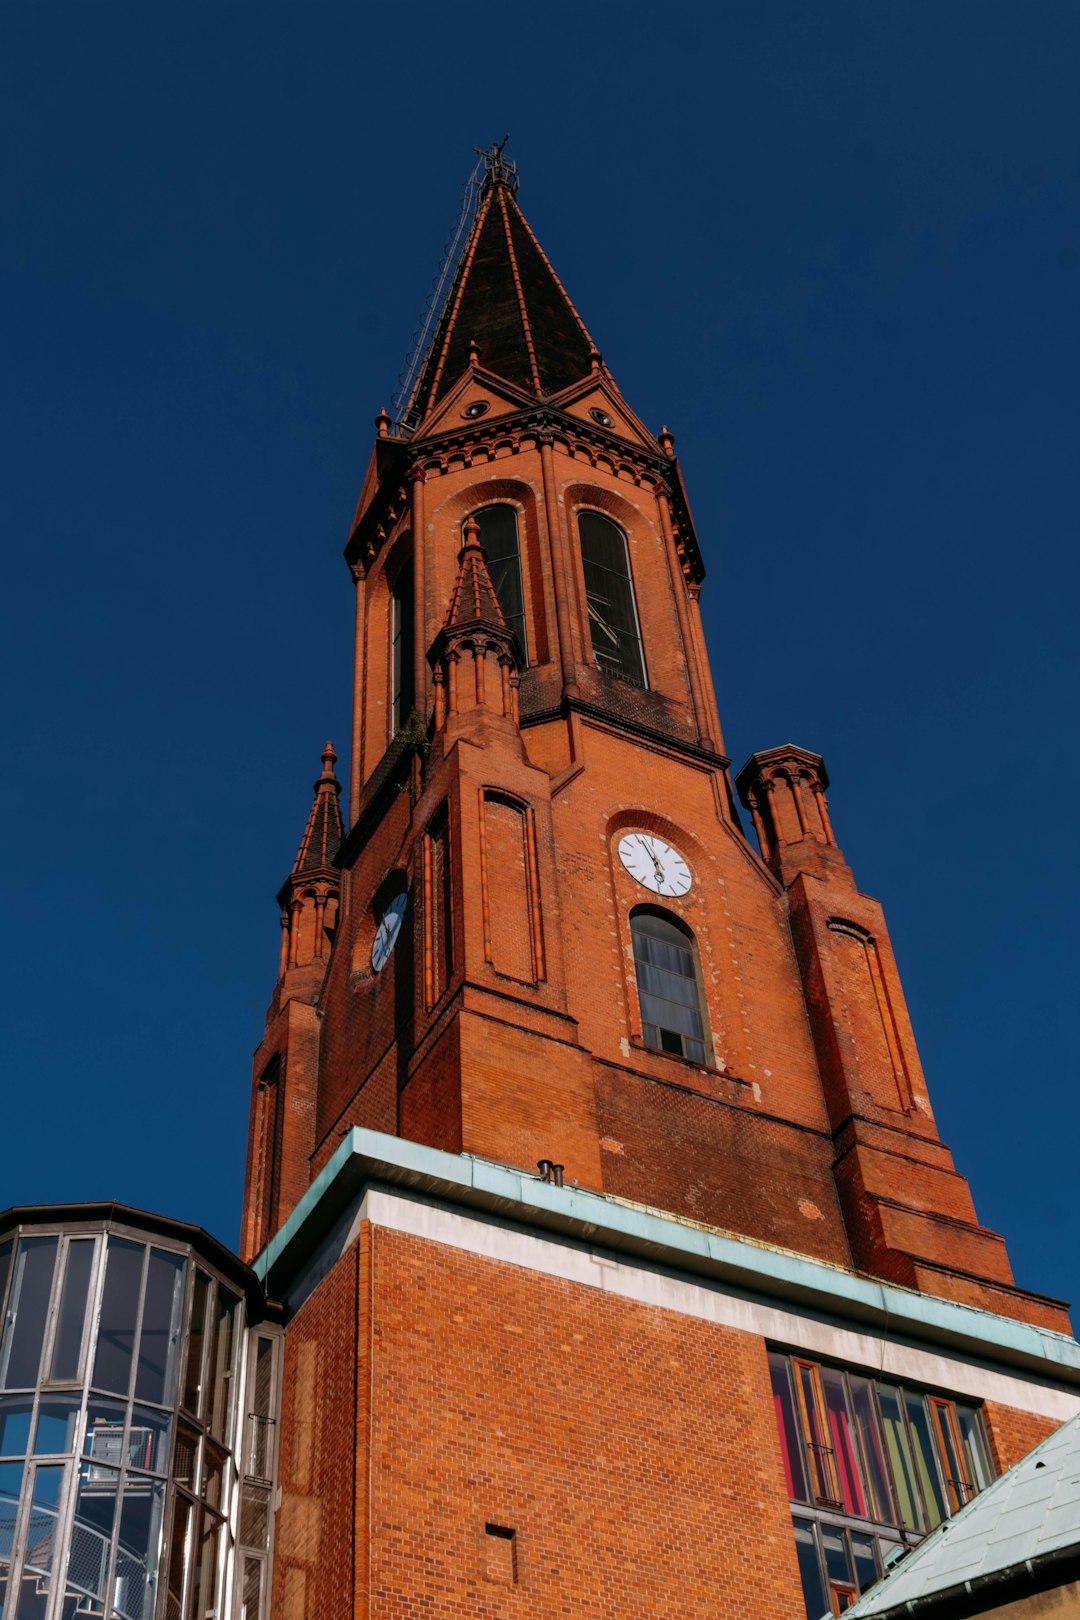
[{"left": 0, "top": 1205, "right": 280, "bottom": 1620}]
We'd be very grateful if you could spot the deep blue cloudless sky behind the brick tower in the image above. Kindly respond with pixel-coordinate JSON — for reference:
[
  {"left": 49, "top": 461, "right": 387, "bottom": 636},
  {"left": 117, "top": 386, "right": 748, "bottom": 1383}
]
[{"left": 0, "top": 0, "right": 1080, "bottom": 1299}]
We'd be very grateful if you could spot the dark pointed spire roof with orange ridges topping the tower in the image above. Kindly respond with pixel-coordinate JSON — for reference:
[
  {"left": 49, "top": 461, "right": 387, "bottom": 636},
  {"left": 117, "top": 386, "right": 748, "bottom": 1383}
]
[{"left": 408, "top": 167, "right": 596, "bottom": 420}]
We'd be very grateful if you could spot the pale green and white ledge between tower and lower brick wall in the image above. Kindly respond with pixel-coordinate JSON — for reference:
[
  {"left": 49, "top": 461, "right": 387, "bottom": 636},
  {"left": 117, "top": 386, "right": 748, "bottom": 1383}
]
[{"left": 253, "top": 1126, "right": 1080, "bottom": 1385}]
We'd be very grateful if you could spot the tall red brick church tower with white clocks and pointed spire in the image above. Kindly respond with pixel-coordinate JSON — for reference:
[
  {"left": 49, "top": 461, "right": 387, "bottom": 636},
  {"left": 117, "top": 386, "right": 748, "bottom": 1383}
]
[{"left": 243, "top": 149, "right": 1080, "bottom": 1620}]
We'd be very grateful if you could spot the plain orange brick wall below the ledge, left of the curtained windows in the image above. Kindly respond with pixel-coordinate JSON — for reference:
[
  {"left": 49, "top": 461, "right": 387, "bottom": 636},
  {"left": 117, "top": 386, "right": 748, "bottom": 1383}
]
[{"left": 359, "top": 1228, "right": 801, "bottom": 1620}]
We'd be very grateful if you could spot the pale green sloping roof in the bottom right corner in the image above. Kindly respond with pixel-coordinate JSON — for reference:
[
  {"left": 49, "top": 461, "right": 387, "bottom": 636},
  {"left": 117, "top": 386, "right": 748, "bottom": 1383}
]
[{"left": 845, "top": 1414, "right": 1080, "bottom": 1620}]
